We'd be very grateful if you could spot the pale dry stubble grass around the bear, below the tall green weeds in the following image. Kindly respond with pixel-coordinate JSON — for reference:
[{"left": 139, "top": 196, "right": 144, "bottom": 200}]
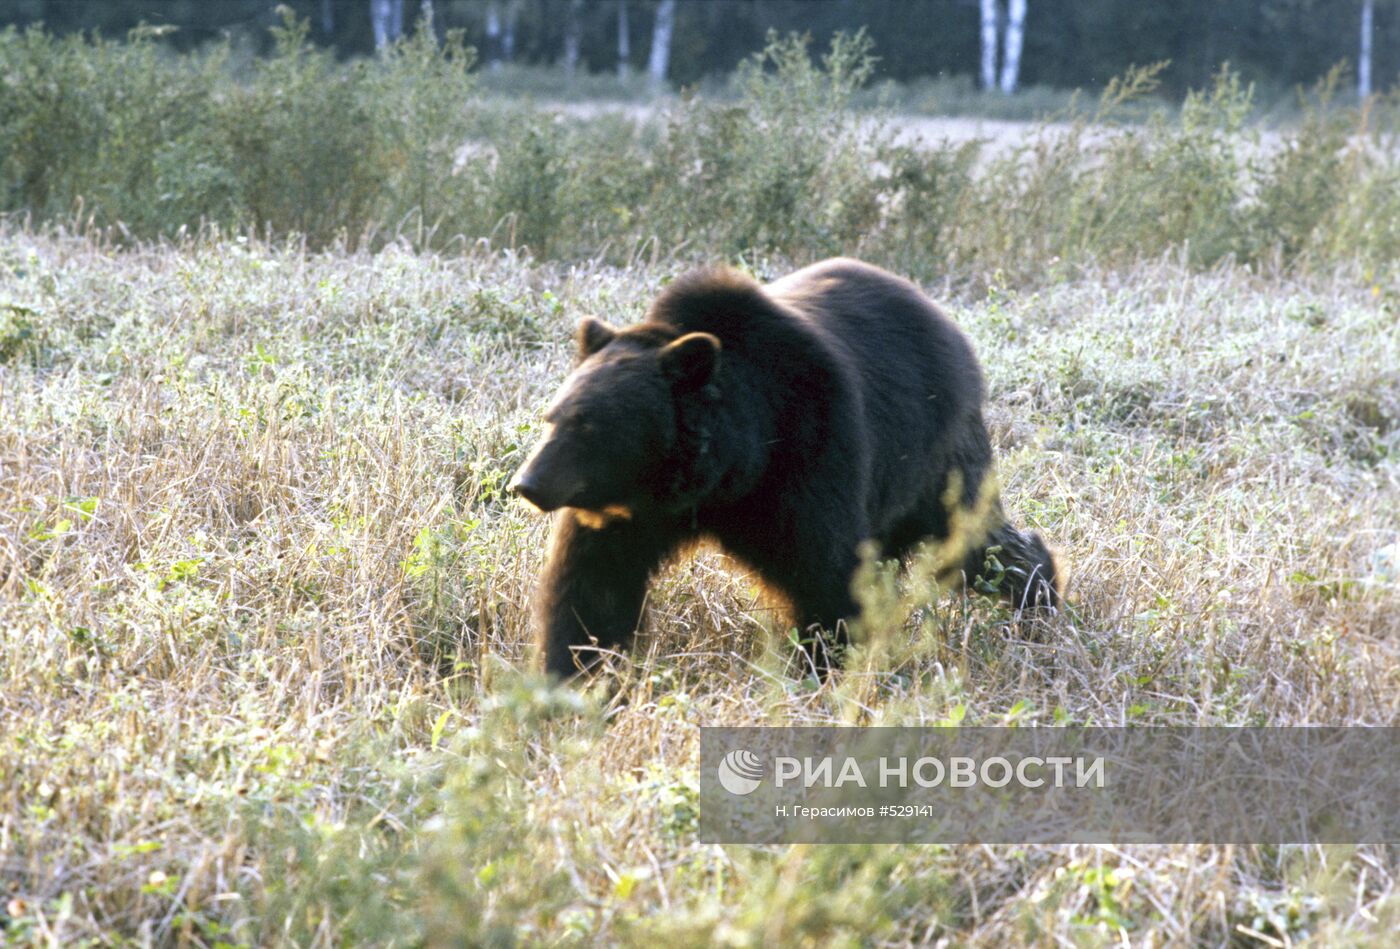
[{"left": 0, "top": 227, "right": 1400, "bottom": 946}]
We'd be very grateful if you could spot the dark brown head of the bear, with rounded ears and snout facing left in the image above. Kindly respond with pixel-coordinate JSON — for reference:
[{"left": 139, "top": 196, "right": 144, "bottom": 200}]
[{"left": 511, "top": 316, "right": 720, "bottom": 512}]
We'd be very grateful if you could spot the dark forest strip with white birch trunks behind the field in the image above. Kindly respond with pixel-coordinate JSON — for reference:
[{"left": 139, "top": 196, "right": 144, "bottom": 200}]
[{"left": 0, "top": 0, "right": 1400, "bottom": 94}]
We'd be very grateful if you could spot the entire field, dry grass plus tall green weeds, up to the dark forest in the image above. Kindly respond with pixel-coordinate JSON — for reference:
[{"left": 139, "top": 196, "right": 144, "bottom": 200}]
[{"left": 0, "top": 21, "right": 1400, "bottom": 946}]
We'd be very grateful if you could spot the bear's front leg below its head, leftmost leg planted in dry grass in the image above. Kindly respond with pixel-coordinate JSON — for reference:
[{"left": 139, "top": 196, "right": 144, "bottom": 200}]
[{"left": 535, "top": 508, "right": 683, "bottom": 679}]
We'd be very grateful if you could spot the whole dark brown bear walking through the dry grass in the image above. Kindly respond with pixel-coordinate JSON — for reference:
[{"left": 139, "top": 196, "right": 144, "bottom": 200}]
[{"left": 511, "top": 259, "right": 1060, "bottom": 676}]
